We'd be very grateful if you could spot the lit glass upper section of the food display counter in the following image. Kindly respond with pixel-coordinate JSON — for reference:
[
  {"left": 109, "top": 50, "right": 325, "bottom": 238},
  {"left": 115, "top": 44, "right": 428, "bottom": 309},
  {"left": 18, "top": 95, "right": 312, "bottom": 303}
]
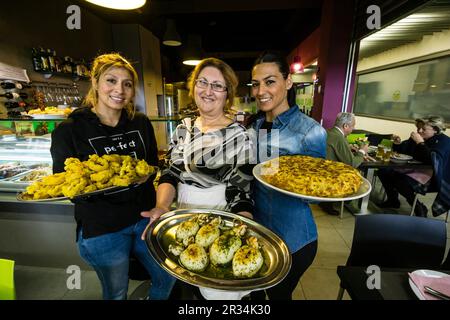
[{"left": 0, "top": 119, "right": 62, "bottom": 192}]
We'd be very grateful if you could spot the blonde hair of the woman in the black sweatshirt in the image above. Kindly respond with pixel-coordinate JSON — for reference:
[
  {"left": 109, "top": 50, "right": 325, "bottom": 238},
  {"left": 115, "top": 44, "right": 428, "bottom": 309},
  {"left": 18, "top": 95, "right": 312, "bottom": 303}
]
[{"left": 84, "top": 53, "right": 138, "bottom": 119}]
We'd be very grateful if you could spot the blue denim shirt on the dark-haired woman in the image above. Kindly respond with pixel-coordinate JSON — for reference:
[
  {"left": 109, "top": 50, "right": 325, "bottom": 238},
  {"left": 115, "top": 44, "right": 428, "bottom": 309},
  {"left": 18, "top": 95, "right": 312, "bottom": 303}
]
[{"left": 252, "top": 106, "right": 327, "bottom": 253}]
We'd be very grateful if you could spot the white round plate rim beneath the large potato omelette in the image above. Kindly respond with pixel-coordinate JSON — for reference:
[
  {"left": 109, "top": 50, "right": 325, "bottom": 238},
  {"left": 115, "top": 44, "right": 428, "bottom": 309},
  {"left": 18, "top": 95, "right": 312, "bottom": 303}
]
[{"left": 253, "top": 160, "right": 372, "bottom": 202}]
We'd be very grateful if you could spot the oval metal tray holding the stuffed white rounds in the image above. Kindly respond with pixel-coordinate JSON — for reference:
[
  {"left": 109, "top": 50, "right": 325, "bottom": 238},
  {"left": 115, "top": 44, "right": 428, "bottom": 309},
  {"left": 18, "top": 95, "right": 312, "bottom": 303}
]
[{"left": 146, "top": 209, "right": 291, "bottom": 291}]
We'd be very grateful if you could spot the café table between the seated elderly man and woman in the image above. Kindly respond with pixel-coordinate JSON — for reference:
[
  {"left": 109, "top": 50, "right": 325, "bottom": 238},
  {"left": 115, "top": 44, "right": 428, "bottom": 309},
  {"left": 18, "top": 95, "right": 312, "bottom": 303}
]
[{"left": 352, "top": 160, "right": 433, "bottom": 214}]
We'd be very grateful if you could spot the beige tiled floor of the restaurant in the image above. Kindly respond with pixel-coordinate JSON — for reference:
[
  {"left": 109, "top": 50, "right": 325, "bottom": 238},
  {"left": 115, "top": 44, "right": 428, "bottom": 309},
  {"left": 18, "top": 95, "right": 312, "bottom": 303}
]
[{"left": 8, "top": 199, "right": 450, "bottom": 300}]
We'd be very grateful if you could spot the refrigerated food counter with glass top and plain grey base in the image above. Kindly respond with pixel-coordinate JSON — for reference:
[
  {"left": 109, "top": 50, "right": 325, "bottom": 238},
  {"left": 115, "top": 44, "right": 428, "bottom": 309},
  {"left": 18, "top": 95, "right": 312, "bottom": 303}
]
[{"left": 0, "top": 119, "right": 81, "bottom": 269}]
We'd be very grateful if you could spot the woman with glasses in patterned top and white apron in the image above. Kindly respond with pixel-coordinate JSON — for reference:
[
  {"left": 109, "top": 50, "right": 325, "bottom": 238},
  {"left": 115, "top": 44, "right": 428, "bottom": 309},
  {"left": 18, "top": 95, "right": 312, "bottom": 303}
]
[{"left": 142, "top": 58, "right": 253, "bottom": 299}]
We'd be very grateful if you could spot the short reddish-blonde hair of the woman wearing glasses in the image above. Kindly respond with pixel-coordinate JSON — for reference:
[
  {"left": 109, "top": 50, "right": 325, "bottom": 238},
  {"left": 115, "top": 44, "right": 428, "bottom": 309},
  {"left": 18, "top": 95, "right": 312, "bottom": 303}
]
[{"left": 188, "top": 58, "right": 239, "bottom": 112}]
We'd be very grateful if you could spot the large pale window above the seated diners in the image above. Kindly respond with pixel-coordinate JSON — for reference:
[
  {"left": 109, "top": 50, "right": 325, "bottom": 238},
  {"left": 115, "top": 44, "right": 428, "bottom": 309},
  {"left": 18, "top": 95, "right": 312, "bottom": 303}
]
[{"left": 353, "top": 55, "right": 450, "bottom": 123}]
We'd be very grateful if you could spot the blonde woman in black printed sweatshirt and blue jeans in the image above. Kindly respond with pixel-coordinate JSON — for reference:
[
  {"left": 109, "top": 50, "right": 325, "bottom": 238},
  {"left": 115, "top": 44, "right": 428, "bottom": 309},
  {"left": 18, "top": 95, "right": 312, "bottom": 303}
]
[{"left": 50, "top": 53, "right": 175, "bottom": 299}]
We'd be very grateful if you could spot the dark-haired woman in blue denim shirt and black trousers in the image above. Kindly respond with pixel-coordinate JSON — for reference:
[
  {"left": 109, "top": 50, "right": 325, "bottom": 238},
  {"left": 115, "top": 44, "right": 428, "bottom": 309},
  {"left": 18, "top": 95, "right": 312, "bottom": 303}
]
[{"left": 252, "top": 52, "right": 327, "bottom": 300}]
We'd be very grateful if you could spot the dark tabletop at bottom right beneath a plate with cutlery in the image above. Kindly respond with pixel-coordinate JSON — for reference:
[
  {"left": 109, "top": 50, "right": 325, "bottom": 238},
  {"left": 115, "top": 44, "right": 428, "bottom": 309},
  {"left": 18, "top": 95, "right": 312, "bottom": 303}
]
[{"left": 337, "top": 266, "right": 450, "bottom": 300}]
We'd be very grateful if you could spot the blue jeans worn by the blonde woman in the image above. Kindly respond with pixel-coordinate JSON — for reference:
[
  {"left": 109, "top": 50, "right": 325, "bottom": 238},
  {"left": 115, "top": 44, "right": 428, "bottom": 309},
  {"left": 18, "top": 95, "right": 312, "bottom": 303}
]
[{"left": 78, "top": 219, "right": 175, "bottom": 300}]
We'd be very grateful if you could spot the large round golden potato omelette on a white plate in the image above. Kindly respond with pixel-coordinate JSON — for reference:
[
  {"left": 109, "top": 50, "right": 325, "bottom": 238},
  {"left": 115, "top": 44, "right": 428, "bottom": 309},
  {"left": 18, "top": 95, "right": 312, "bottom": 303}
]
[{"left": 261, "top": 155, "right": 363, "bottom": 198}]
